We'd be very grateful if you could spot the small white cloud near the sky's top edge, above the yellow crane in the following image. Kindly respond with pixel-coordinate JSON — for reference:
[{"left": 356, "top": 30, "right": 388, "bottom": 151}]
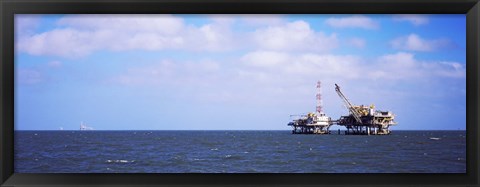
[{"left": 326, "top": 15, "right": 380, "bottom": 29}]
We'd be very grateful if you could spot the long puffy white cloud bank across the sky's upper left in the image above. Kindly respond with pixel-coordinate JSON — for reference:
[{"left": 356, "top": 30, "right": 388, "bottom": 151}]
[{"left": 17, "top": 15, "right": 236, "bottom": 58}]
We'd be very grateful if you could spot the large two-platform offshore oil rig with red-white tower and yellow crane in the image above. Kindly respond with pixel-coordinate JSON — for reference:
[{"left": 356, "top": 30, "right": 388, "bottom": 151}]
[{"left": 288, "top": 81, "right": 397, "bottom": 135}]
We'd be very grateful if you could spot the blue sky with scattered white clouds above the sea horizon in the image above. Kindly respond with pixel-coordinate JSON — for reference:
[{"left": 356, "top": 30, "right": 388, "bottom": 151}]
[{"left": 15, "top": 14, "right": 466, "bottom": 130}]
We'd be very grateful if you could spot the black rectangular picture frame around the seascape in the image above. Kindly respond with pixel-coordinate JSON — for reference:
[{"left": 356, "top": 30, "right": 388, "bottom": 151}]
[{"left": 0, "top": 0, "right": 480, "bottom": 186}]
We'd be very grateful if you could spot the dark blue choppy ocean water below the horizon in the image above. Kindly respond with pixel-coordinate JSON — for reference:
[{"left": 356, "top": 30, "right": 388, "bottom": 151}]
[{"left": 14, "top": 130, "right": 466, "bottom": 173}]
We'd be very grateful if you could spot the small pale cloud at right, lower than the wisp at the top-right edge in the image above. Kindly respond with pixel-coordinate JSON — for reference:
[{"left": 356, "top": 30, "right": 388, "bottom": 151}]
[{"left": 390, "top": 34, "right": 451, "bottom": 51}]
